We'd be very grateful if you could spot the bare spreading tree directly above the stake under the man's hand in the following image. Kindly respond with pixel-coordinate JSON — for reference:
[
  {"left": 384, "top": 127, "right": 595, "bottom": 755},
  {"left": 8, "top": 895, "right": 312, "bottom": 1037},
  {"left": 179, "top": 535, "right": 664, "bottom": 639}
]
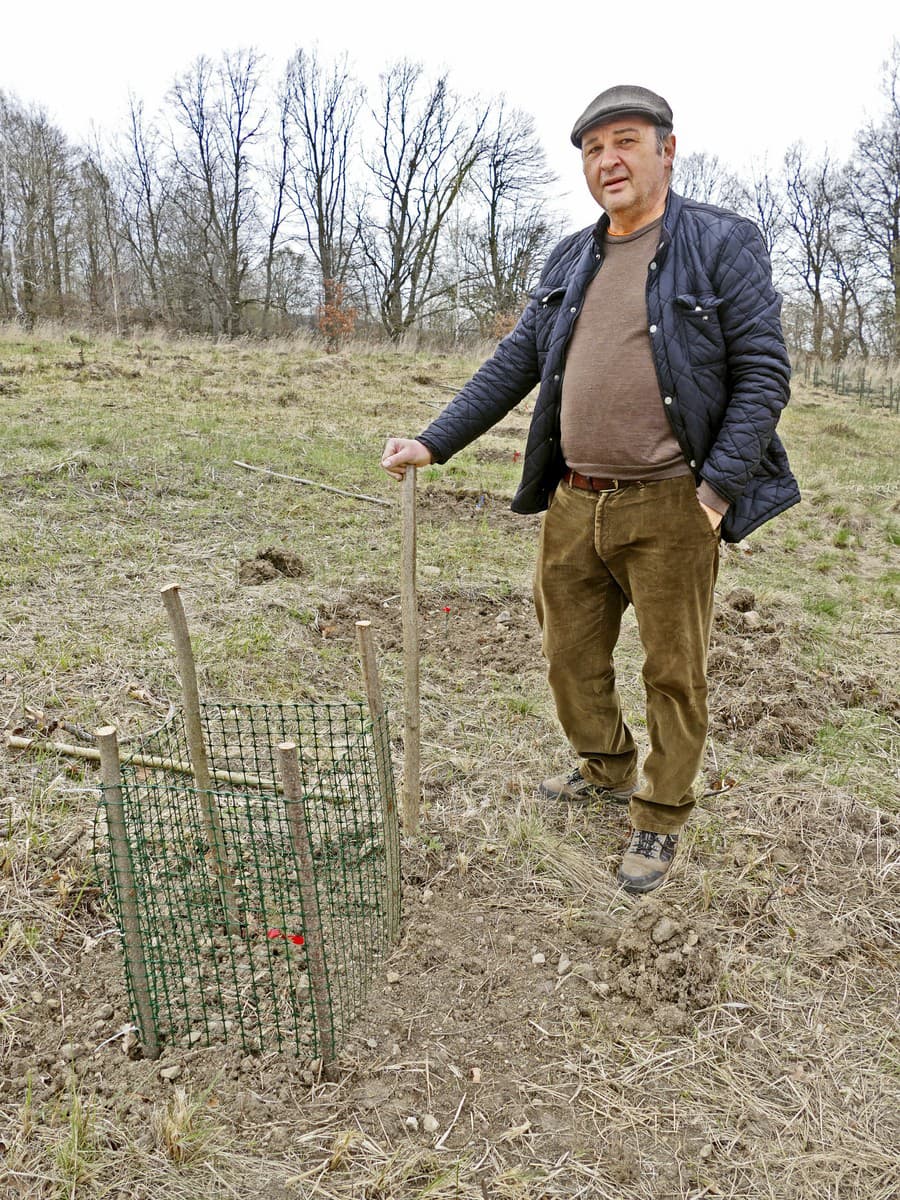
[{"left": 360, "top": 61, "right": 487, "bottom": 340}]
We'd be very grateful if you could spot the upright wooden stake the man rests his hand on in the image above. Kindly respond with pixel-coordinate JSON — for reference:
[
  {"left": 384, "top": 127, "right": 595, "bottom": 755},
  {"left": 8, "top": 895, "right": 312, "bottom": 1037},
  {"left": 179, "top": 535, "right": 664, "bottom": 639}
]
[{"left": 400, "top": 467, "right": 421, "bottom": 835}]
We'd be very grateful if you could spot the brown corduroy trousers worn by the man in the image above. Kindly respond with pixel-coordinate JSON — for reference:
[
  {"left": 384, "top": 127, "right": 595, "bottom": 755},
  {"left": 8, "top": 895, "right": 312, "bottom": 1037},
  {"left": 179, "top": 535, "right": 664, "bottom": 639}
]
[{"left": 534, "top": 475, "right": 719, "bottom": 834}]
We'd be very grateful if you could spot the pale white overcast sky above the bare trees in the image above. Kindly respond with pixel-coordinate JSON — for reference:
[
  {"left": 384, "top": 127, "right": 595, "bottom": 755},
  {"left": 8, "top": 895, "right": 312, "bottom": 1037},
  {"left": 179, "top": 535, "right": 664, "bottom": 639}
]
[{"left": 0, "top": 0, "right": 900, "bottom": 224}]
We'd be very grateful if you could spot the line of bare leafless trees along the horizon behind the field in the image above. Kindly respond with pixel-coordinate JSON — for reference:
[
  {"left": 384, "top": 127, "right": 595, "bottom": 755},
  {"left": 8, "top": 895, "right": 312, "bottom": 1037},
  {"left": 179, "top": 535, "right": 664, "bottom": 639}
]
[{"left": 0, "top": 40, "right": 900, "bottom": 361}]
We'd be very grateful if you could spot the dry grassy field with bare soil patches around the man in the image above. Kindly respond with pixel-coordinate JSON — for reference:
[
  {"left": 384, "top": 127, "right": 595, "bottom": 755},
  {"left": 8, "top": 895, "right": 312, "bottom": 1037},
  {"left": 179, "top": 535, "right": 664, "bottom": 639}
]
[{"left": 0, "top": 329, "right": 900, "bottom": 1200}]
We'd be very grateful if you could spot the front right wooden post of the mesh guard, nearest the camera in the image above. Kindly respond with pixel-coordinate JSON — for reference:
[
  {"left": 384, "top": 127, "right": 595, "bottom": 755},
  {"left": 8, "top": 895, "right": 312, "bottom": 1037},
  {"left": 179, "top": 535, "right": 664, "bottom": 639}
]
[{"left": 278, "top": 742, "right": 335, "bottom": 1078}]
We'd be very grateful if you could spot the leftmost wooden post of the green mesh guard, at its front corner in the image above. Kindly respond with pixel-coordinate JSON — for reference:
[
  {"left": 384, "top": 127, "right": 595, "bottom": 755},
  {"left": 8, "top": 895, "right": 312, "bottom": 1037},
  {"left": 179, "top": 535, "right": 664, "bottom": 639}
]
[{"left": 96, "top": 725, "right": 160, "bottom": 1058}]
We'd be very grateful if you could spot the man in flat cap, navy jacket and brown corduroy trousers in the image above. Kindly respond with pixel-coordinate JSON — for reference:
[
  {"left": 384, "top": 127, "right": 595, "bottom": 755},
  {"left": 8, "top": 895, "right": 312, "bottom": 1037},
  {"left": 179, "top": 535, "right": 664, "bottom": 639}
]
[{"left": 382, "top": 85, "right": 799, "bottom": 894}]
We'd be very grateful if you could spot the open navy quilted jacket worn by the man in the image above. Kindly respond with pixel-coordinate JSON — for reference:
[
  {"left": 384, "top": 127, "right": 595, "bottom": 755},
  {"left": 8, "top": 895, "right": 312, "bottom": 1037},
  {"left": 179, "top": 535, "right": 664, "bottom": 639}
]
[{"left": 419, "top": 191, "right": 800, "bottom": 541}]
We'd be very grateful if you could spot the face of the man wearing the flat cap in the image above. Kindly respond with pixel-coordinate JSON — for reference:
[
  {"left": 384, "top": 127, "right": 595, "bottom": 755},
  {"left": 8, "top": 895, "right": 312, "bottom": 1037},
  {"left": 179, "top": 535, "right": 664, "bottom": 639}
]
[{"left": 581, "top": 116, "right": 674, "bottom": 234}]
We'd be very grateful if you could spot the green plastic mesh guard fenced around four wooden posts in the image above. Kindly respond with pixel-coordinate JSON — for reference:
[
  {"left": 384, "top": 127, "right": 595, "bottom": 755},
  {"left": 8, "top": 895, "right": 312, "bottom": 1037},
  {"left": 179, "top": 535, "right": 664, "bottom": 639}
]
[{"left": 94, "top": 702, "right": 398, "bottom": 1058}]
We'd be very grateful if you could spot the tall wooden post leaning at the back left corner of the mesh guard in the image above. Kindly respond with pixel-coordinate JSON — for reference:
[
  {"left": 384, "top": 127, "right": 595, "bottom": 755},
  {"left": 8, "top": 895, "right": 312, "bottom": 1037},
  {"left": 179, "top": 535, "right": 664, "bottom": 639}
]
[{"left": 162, "top": 583, "right": 240, "bottom": 934}]
